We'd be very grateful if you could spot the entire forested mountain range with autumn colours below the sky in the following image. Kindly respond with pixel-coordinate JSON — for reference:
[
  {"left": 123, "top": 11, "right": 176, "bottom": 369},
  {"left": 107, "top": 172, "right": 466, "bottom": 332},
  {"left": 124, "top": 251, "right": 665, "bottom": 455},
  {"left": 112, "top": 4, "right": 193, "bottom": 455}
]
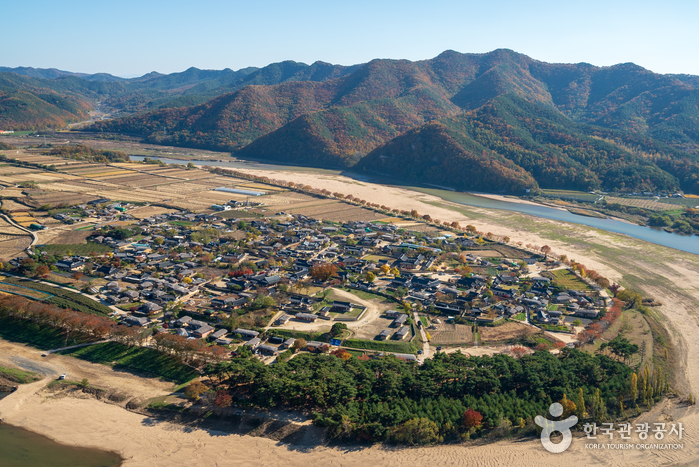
[{"left": 0, "top": 50, "right": 699, "bottom": 193}]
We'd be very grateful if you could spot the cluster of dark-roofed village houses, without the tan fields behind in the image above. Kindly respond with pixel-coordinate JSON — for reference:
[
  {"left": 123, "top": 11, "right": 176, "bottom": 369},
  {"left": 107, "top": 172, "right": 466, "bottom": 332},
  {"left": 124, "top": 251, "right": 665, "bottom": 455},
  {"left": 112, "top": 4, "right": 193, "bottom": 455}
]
[{"left": 5, "top": 200, "right": 607, "bottom": 363}]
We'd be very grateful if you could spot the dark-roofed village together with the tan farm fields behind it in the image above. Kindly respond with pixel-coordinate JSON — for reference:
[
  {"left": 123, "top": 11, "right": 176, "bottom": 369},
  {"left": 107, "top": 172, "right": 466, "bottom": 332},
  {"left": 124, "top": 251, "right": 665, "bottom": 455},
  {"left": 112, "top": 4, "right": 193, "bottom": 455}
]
[{"left": 0, "top": 149, "right": 611, "bottom": 363}]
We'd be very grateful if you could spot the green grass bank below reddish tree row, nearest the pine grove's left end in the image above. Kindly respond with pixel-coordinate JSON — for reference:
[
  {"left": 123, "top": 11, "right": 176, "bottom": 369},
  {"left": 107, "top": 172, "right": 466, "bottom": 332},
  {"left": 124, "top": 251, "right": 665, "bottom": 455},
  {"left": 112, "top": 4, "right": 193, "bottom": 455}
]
[{"left": 61, "top": 342, "right": 199, "bottom": 384}]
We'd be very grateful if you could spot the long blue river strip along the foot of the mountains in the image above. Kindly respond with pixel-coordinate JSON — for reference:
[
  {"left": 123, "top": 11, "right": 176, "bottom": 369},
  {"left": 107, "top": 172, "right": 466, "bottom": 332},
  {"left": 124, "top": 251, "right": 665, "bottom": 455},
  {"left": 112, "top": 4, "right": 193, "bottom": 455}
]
[{"left": 131, "top": 156, "right": 699, "bottom": 254}]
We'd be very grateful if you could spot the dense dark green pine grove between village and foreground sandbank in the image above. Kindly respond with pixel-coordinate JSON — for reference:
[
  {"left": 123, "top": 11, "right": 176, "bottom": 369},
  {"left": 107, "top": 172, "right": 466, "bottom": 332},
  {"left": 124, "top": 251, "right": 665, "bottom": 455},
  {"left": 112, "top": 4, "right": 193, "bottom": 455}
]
[{"left": 209, "top": 348, "right": 652, "bottom": 443}]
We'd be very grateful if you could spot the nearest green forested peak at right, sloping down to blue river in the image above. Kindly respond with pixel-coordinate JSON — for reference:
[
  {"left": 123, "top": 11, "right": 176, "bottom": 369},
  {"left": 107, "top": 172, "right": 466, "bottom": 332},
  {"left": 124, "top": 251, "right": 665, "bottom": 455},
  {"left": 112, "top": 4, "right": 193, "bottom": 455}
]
[{"left": 357, "top": 94, "right": 699, "bottom": 192}]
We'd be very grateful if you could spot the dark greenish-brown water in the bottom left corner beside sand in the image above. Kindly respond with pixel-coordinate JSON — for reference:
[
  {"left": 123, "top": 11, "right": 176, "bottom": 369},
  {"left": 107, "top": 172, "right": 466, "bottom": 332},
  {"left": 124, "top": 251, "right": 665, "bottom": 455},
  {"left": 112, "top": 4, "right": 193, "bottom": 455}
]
[{"left": 0, "top": 423, "right": 123, "bottom": 467}]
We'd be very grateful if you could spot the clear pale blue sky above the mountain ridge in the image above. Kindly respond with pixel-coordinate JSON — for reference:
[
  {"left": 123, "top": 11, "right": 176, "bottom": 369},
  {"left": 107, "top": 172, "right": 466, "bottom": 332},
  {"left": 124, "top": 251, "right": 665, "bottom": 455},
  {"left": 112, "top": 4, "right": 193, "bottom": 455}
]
[{"left": 5, "top": 0, "right": 699, "bottom": 77}]
